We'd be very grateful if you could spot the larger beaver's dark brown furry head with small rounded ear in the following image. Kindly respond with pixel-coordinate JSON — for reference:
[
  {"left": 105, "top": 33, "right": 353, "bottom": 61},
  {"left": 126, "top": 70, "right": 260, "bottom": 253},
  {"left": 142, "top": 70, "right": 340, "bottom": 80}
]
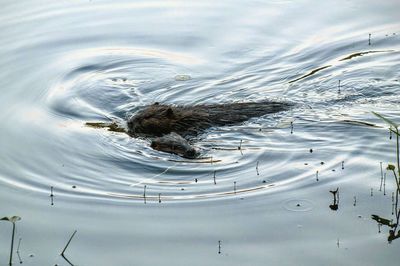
[{"left": 128, "top": 103, "right": 175, "bottom": 137}]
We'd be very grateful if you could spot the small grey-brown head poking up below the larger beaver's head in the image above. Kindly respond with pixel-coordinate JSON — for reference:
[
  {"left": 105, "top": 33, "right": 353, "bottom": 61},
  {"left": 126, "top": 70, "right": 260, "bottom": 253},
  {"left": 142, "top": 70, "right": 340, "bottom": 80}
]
[{"left": 151, "top": 132, "right": 199, "bottom": 159}]
